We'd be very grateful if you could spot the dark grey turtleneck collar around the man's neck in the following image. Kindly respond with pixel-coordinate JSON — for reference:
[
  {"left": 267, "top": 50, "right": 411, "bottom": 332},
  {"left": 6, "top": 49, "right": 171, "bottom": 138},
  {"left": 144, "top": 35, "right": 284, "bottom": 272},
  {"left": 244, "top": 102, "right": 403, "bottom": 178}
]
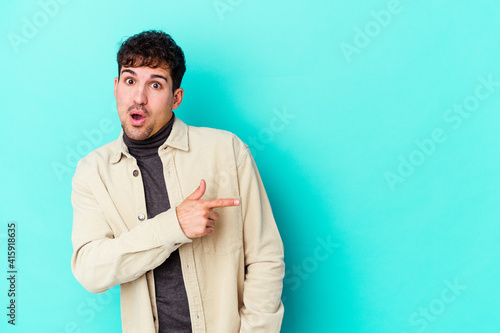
[{"left": 123, "top": 113, "right": 175, "bottom": 158}]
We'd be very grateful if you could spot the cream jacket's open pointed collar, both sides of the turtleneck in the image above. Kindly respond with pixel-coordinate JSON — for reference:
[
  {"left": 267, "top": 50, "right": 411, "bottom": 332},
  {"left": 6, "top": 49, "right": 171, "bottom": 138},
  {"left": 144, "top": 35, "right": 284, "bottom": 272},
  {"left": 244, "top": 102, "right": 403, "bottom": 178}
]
[{"left": 110, "top": 116, "right": 189, "bottom": 164}]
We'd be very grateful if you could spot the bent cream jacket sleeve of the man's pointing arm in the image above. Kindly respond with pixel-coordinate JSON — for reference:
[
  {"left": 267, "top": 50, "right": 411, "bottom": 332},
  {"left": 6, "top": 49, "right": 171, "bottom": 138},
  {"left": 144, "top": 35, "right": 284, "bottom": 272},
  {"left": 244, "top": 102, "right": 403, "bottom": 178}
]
[{"left": 71, "top": 157, "right": 191, "bottom": 293}]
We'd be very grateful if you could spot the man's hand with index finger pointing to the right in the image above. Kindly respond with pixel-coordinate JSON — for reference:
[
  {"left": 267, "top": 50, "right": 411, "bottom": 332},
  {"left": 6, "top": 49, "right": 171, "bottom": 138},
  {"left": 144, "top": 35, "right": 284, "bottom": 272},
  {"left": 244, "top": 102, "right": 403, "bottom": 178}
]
[{"left": 176, "top": 179, "right": 240, "bottom": 238}]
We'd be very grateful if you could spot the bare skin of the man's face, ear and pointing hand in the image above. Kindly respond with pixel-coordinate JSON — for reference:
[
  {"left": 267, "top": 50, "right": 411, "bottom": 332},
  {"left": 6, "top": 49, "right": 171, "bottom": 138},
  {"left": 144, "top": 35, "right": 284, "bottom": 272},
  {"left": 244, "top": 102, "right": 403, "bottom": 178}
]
[{"left": 114, "top": 67, "right": 240, "bottom": 239}]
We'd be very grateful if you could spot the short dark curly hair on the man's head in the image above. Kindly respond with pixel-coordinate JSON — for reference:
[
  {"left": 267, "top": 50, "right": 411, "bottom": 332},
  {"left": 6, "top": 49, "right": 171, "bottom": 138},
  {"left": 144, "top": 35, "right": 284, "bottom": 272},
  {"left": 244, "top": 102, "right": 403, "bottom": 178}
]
[{"left": 116, "top": 30, "right": 186, "bottom": 91}]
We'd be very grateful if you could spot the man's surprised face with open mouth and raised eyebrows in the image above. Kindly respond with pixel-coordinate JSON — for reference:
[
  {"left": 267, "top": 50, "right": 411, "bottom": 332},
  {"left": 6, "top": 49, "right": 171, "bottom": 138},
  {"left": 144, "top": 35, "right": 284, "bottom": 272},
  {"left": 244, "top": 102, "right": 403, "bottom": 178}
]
[{"left": 115, "top": 67, "right": 184, "bottom": 140}]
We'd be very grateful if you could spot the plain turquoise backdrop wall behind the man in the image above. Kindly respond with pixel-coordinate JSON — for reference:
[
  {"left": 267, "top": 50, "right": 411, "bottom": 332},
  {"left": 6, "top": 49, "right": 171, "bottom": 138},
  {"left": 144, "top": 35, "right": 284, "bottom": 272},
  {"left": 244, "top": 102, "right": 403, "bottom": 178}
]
[{"left": 0, "top": 0, "right": 500, "bottom": 333}]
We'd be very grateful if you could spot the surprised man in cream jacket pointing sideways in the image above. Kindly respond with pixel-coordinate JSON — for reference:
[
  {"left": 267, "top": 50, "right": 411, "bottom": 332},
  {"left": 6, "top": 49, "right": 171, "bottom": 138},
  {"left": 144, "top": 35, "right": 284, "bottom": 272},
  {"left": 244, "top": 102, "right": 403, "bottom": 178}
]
[{"left": 71, "top": 31, "right": 284, "bottom": 333}]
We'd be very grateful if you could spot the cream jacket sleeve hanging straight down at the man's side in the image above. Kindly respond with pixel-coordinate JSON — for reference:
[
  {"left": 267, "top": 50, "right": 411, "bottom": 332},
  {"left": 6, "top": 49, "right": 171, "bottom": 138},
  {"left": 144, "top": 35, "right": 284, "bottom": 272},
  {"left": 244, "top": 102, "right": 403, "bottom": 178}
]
[{"left": 238, "top": 146, "right": 285, "bottom": 333}]
